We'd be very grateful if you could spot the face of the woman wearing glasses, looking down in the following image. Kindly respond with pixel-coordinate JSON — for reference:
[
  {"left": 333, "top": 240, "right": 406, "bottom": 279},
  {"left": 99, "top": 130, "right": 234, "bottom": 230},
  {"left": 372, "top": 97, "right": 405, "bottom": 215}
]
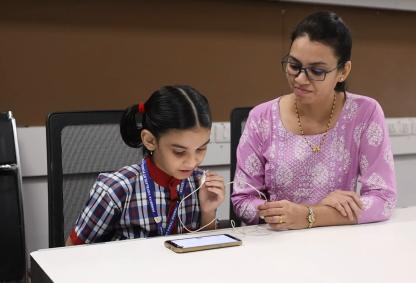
[{"left": 286, "top": 35, "right": 351, "bottom": 104}]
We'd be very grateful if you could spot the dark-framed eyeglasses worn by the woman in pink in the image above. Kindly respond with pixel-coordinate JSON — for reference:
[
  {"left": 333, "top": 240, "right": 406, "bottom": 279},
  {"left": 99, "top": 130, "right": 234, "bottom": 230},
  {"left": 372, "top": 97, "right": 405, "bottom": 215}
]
[{"left": 281, "top": 56, "right": 342, "bottom": 81}]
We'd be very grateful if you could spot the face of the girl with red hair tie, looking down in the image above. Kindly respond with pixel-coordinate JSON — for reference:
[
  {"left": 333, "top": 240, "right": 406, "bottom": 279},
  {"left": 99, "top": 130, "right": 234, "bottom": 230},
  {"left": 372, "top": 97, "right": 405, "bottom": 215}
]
[{"left": 142, "top": 127, "right": 211, "bottom": 180}]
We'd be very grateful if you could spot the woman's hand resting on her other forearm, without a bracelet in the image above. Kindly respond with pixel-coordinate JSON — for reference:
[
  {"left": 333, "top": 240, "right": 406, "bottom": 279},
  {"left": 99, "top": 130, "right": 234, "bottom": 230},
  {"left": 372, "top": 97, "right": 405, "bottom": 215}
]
[{"left": 320, "top": 190, "right": 363, "bottom": 221}]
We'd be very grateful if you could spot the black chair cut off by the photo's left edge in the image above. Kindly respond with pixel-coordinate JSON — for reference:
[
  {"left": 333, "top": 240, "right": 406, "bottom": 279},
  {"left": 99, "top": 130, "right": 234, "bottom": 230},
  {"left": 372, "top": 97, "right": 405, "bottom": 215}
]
[{"left": 0, "top": 111, "right": 27, "bottom": 282}]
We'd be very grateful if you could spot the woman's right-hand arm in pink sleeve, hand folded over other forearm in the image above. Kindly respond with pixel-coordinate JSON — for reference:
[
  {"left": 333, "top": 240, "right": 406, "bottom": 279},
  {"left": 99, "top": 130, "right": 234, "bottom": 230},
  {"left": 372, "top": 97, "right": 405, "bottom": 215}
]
[{"left": 306, "top": 101, "right": 396, "bottom": 225}]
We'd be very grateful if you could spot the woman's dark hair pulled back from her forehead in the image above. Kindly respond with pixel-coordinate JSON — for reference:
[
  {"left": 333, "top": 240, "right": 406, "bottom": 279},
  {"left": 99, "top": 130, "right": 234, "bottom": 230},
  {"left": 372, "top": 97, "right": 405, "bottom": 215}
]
[{"left": 291, "top": 11, "right": 352, "bottom": 91}]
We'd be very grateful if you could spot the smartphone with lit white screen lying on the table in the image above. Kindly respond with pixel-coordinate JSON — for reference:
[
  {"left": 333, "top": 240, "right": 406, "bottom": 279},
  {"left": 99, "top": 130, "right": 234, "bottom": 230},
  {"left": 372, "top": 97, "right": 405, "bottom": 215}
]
[{"left": 165, "top": 234, "right": 243, "bottom": 253}]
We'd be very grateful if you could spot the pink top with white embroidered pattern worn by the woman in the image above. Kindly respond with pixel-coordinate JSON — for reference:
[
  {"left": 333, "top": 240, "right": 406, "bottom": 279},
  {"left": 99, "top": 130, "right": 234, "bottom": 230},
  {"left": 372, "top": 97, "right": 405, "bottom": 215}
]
[{"left": 232, "top": 93, "right": 396, "bottom": 224}]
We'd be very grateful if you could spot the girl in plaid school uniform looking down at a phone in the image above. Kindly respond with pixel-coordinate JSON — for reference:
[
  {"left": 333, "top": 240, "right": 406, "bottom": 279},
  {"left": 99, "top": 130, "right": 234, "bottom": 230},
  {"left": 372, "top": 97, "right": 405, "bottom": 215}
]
[{"left": 66, "top": 86, "right": 224, "bottom": 245}]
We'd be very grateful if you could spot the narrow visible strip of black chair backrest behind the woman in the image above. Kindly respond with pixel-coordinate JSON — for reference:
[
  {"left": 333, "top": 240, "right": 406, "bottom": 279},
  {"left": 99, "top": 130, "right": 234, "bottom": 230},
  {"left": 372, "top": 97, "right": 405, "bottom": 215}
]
[{"left": 230, "top": 107, "right": 253, "bottom": 226}]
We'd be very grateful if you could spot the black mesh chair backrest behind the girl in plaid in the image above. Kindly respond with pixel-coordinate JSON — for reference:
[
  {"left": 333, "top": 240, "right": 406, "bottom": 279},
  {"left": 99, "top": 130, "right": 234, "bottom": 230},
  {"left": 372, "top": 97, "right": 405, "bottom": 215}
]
[{"left": 46, "top": 110, "right": 142, "bottom": 247}]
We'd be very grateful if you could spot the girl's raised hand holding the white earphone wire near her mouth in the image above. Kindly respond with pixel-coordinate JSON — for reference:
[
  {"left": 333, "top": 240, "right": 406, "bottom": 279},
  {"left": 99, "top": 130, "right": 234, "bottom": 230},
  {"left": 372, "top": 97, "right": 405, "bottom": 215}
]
[{"left": 199, "top": 171, "right": 225, "bottom": 212}]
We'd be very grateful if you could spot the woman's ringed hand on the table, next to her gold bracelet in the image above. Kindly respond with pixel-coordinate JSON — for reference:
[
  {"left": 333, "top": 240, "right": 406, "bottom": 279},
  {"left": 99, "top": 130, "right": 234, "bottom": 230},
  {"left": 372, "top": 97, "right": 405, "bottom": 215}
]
[{"left": 258, "top": 200, "right": 308, "bottom": 230}]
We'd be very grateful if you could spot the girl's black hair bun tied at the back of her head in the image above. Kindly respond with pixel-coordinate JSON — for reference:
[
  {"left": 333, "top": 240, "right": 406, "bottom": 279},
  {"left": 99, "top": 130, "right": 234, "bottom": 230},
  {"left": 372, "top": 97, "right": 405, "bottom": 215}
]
[{"left": 120, "top": 104, "right": 144, "bottom": 148}]
